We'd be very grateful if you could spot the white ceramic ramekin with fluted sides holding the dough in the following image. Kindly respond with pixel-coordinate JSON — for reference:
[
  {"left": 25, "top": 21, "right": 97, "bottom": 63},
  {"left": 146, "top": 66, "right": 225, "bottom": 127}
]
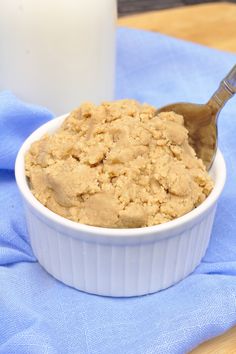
[{"left": 15, "top": 116, "right": 226, "bottom": 296}]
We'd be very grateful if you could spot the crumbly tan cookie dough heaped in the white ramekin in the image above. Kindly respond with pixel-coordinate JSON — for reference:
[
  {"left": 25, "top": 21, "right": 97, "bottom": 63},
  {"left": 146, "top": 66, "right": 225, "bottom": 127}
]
[{"left": 25, "top": 99, "right": 213, "bottom": 228}]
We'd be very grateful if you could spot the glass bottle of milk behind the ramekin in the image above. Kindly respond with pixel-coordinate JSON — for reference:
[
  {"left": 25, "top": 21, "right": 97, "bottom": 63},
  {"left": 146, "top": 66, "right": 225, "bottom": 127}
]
[{"left": 0, "top": 0, "right": 116, "bottom": 115}]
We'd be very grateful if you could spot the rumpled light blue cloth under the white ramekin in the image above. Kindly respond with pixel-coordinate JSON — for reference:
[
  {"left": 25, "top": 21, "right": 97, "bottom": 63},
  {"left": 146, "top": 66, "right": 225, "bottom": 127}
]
[{"left": 0, "top": 29, "right": 236, "bottom": 354}]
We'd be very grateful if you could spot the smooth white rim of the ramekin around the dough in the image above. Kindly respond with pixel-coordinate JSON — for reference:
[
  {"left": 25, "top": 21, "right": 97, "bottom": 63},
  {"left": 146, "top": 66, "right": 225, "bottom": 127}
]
[{"left": 15, "top": 115, "right": 226, "bottom": 236}]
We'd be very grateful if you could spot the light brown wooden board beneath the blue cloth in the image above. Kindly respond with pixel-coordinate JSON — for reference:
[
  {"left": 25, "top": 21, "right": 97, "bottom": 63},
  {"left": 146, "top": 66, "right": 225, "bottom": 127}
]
[{"left": 118, "top": 2, "right": 236, "bottom": 354}]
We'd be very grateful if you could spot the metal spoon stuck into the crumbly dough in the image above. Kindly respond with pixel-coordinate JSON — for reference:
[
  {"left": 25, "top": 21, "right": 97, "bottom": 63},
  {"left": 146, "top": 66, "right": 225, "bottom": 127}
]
[{"left": 157, "top": 65, "right": 236, "bottom": 170}]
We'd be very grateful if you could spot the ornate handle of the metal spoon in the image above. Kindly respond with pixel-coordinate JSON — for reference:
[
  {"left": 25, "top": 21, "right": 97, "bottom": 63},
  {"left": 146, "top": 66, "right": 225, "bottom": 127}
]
[{"left": 207, "top": 65, "right": 236, "bottom": 113}]
